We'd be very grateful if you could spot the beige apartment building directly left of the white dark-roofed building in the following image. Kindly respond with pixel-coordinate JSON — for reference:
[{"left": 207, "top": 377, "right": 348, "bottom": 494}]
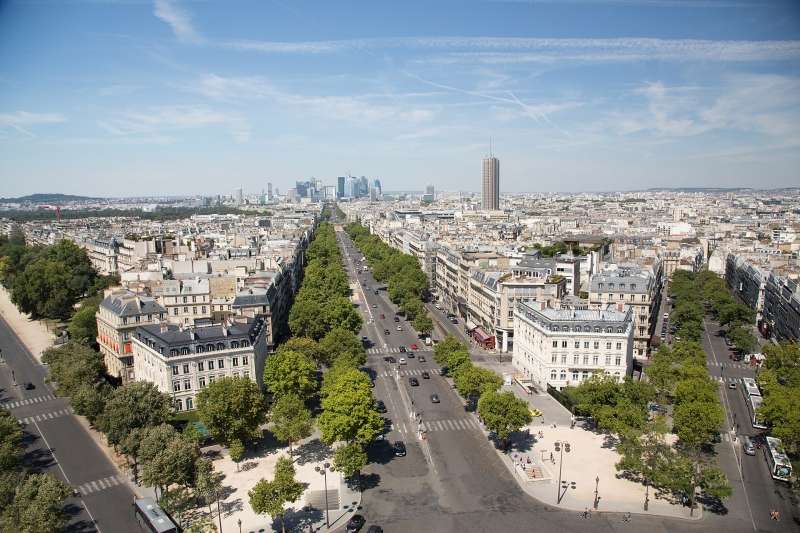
[{"left": 96, "top": 288, "right": 167, "bottom": 383}]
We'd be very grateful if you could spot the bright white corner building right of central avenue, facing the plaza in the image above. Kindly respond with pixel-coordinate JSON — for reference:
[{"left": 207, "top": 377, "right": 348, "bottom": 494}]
[{"left": 512, "top": 303, "right": 635, "bottom": 391}]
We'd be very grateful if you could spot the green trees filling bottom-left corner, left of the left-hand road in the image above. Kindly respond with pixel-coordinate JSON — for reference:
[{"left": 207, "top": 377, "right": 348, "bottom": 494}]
[{"left": 0, "top": 408, "right": 72, "bottom": 533}]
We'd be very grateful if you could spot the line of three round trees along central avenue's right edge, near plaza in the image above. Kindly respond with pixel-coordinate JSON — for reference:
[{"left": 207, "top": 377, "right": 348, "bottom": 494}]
[{"left": 433, "top": 335, "right": 533, "bottom": 447}]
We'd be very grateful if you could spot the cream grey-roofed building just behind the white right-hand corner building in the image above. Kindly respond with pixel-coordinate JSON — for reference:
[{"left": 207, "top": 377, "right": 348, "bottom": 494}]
[{"left": 589, "top": 261, "right": 662, "bottom": 357}]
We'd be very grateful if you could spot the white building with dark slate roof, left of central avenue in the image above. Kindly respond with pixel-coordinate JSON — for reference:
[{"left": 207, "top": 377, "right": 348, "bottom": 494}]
[{"left": 133, "top": 317, "right": 268, "bottom": 411}]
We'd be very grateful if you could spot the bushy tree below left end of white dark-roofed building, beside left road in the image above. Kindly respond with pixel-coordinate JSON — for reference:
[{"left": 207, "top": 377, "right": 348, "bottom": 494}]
[{"left": 98, "top": 381, "right": 172, "bottom": 447}]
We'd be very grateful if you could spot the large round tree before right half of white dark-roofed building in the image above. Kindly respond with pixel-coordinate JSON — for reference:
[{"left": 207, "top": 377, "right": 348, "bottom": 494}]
[{"left": 197, "top": 377, "right": 267, "bottom": 446}]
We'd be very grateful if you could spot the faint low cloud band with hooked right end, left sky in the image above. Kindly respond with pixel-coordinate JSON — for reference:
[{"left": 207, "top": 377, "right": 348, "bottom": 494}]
[{"left": 98, "top": 106, "right": 250, "bottom": 142}]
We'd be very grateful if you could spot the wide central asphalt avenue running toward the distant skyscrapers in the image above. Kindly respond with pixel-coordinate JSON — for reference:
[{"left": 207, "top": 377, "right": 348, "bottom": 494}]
[{"left": 338, "top": 228, "right": 752, "bottom": 533}]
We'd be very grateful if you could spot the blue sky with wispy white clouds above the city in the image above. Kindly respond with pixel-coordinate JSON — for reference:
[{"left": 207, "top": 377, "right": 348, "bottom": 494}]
[{"left": 0, "top": 0, "right": 800, "bottom": 196}]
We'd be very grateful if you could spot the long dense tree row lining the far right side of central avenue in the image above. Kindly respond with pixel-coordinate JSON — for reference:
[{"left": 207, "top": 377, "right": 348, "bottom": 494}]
[{"left": 345, "top": 223, "right": 433, "bottom": 335}]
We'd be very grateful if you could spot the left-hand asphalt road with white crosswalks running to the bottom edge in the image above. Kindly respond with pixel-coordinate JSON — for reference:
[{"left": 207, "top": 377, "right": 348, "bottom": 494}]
[{"left": 0, "top": 319, "right": 140, "bottom": 533}]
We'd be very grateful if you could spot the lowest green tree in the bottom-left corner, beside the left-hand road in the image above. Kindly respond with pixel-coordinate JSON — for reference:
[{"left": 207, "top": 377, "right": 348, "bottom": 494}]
[{"left": 2, "top": 474, "right": 72, "bottom": 533}]
